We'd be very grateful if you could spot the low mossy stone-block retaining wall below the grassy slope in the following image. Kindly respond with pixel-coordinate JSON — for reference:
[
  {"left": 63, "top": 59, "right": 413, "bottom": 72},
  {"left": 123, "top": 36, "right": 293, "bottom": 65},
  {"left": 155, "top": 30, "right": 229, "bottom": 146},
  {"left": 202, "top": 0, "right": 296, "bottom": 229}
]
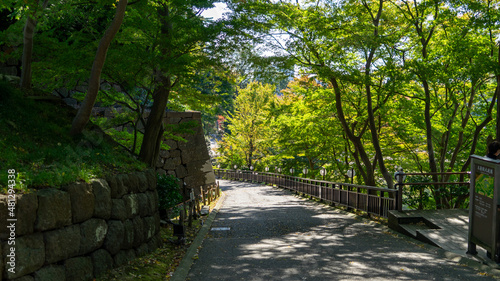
[{"left": 0, "top": 170, "right": 161, "bottom": 281}]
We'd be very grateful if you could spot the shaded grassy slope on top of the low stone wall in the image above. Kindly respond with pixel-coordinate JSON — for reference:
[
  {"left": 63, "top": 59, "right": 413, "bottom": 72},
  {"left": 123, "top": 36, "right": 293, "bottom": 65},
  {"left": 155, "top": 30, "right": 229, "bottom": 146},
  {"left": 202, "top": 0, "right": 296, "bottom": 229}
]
[{"left": 0, "top": 82, "right": 146, "bottom": 193}]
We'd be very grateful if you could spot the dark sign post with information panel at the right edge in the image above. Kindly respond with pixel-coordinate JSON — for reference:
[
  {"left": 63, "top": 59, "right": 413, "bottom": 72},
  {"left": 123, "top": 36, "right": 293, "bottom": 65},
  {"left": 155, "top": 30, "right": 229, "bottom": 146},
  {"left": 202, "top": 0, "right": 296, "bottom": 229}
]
[{"left": 467, "top": 155, "right": 500, "bottom": 262}]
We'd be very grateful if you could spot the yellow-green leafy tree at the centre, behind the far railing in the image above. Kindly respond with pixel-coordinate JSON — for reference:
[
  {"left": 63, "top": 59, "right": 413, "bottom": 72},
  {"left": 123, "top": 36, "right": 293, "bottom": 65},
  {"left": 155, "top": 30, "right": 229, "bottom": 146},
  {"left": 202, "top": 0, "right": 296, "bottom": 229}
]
[{"left": 271, "top": 76, "right": 348, "bottom": 179}]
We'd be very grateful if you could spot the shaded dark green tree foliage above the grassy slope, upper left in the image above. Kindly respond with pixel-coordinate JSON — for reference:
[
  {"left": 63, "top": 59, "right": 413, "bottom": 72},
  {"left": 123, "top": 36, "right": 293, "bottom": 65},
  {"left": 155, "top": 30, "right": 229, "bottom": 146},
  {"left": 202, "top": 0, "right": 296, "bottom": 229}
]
[{"left": 0, "top": 0, "right": 235, "bottom": 164}]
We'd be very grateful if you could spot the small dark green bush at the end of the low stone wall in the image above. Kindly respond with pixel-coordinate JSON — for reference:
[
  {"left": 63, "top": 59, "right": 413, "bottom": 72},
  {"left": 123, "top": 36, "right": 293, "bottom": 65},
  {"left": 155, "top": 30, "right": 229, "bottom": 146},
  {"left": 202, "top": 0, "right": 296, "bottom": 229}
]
[{"left": 156, "top": 175, "right": 183, "bottom": 210}]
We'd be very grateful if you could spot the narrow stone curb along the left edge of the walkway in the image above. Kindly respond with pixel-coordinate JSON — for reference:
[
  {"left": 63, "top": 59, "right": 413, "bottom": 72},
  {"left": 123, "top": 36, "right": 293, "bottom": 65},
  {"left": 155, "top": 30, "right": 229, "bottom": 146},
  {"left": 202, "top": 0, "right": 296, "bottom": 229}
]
[{"left": 170, "top": 188, "right": 226, "bottom": 281}]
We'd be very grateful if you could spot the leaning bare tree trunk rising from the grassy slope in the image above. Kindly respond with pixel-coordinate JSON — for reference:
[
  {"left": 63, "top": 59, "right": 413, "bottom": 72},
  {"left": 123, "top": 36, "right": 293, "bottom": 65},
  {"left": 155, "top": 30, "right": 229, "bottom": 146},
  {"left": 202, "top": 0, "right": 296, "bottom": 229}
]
[{"left": 70, "top": 0, "right": 128, "bottom": 135}]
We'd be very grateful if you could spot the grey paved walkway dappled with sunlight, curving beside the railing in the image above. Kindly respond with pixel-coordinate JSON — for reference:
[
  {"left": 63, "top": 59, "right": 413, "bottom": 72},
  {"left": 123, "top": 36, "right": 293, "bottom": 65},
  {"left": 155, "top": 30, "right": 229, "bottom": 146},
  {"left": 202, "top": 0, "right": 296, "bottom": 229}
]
[{"left": 187, "top": 181, "right": 496, "bottom": 281}]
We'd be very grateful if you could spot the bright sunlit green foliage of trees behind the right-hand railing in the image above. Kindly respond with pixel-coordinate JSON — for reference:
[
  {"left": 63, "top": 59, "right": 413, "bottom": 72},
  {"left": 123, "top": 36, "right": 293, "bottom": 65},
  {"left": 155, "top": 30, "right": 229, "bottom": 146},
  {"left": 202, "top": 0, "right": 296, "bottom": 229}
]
[{"left": 224, "top": 1, "right": 500, "bottom": 187}]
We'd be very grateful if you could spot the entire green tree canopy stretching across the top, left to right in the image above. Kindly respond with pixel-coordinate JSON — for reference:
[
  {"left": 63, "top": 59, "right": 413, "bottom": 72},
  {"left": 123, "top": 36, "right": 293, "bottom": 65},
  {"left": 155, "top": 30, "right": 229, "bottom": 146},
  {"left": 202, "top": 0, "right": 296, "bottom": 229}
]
[{"left": 0, "top": 0, "right": 500, "bottom": 187}]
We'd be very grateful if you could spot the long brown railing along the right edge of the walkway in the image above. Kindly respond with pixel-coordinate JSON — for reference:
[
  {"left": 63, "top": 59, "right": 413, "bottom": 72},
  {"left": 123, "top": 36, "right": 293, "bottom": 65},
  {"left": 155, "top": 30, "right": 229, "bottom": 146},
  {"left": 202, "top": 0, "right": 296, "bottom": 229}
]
[{"left": 214, "top": 169, "right": 402, "bottom": 218}]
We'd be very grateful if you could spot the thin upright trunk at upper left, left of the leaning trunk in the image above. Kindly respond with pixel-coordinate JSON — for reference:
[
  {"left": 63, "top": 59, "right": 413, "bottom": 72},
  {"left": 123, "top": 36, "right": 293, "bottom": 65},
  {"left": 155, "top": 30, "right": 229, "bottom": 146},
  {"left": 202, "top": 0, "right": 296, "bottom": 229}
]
[{"left": 20, "top": 0, "right": 49, "bottom": 90}]
